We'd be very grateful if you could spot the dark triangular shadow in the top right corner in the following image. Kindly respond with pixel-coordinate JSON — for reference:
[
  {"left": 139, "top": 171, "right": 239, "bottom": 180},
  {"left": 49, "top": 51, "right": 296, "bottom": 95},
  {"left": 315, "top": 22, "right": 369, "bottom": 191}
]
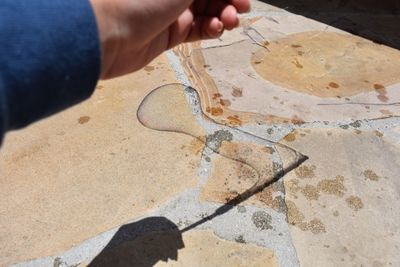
[{"left": 260, "top": 0, "right": 400, "bottom": 49}]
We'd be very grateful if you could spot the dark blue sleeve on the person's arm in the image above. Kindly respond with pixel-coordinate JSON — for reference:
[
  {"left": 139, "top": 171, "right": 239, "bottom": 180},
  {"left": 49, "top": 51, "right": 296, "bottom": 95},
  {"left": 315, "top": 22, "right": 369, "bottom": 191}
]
[{"left": 0, "top": 0, "right": 100, "bottom": 144}]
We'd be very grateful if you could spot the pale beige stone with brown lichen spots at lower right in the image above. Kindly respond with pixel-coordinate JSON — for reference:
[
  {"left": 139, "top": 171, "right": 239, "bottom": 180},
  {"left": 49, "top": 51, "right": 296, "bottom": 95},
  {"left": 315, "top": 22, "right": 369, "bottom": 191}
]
[{"left": 284, "top": 129, "right": 400, "bottom": 266}]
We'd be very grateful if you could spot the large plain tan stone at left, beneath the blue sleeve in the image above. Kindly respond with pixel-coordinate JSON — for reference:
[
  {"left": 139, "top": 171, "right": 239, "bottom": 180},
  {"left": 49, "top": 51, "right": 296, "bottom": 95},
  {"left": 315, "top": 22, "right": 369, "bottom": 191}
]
[{"left": 0, "top": 56, "right": 199, "bottom": 266}]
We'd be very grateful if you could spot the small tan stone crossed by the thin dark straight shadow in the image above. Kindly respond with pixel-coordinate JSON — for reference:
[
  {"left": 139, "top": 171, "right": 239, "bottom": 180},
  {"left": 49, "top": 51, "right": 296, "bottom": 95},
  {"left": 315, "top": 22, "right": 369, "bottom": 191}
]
[{"left": 200, "top": 142, "right": 284, "bottom": 214}]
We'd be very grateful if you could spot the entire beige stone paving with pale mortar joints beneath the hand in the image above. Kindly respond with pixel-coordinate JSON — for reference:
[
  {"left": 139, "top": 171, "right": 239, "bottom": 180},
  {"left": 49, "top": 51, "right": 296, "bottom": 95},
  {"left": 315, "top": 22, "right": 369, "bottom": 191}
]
[{"left": 0, "top": 0, "right": 400, "bottom": 267}]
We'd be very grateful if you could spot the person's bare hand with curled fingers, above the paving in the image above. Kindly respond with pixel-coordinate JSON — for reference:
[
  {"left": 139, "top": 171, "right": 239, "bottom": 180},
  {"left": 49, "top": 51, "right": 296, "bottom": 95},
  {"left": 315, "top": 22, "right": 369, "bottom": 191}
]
[{"left": 90, "top": 0, "right": 250, "bottom": 79}]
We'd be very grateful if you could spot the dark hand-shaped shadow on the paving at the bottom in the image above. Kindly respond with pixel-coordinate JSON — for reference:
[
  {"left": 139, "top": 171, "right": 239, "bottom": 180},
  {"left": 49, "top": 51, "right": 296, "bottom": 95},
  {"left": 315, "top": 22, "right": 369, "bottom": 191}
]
[{"left": 88, "top": 217, "right": 185, "bottom": 267}]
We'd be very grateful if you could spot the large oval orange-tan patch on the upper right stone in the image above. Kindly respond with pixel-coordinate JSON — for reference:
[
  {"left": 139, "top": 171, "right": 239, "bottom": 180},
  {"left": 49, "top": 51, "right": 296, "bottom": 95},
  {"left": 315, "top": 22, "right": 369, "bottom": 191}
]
[{"left": 251, "top": 32, "right": 400, "bottom": 97}]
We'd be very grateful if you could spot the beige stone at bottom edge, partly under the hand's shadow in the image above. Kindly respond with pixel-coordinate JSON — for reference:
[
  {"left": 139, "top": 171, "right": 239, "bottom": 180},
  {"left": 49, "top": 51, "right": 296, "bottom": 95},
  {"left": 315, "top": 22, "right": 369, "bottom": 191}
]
[{"left": 86, "top": 231, "right": 278, "bottom": 267}]
